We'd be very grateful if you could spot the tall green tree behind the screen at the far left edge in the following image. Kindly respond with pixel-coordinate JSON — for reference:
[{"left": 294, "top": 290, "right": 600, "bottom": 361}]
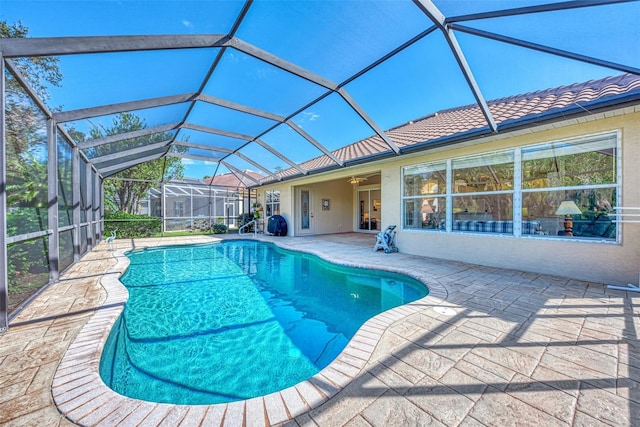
[{"left": 0, "top": 21, "right": 62, "bottom": 311}]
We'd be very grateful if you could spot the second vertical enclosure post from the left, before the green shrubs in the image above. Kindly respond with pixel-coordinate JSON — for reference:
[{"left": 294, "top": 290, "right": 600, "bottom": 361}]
[{"left": 47, "top": 119, "right": 60, "bottom": 282}]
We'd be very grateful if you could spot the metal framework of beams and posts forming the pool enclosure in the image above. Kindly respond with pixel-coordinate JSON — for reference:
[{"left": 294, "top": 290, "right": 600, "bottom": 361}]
[{"left": 0, "top": 0, "right": 640, "bottom": 333}]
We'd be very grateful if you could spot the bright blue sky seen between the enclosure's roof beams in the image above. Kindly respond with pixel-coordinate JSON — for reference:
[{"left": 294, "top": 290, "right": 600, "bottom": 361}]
[{"left": 0, "top": 0, "right": 640, "bottom": 177}]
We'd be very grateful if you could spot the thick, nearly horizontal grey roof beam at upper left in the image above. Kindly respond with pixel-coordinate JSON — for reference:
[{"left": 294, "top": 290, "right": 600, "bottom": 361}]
[{"left": 0, "top": 34, "right": 228, "bottom": 58}]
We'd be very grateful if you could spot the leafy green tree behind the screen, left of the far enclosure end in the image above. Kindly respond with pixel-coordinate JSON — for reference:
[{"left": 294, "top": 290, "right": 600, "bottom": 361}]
[{"left": 94, "top": 113, "right": 184, "bottom": 214}]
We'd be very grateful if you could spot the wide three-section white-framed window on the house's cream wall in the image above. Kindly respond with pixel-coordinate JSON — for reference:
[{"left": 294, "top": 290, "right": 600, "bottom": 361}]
[{"left": 403, "top": 133, "right": 620, "bottom": 241}]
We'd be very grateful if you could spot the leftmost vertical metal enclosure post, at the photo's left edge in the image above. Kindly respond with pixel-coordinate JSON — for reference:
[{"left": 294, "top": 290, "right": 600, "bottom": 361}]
[{"left": 0, "top": 52, "right": 9, "bottom": 335}]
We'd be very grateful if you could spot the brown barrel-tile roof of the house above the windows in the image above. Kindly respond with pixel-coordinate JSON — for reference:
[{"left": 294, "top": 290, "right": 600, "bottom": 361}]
[{"left": 263, "top": 74, "right": 640, "bottom": 182}]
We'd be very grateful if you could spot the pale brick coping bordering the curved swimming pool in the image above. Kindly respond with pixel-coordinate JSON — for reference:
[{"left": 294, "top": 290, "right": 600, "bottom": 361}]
[{"left": 51, "top": 237, "right": 447, "bottom": 425}]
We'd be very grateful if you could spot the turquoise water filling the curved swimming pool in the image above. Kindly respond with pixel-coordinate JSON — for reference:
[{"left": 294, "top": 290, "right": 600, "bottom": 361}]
[{"left": 100, "top": 241, "right": 428, "bottom": 404}]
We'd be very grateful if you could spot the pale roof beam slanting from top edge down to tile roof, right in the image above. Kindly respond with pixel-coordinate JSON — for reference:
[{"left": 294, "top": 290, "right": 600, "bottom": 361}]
[{"left": 413, "top": 0, "right": 498, "bottom": 132}]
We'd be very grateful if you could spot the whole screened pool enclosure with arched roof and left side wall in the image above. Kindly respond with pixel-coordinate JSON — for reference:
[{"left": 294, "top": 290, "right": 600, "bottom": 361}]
[{"left": 0, "top": 0, "right": 640, "bottom": 332}]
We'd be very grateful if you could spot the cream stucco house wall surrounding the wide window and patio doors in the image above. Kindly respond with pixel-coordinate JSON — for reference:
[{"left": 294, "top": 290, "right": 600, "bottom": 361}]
[{"left": 256, "top": 112, "right": 640, "bottom": 285}]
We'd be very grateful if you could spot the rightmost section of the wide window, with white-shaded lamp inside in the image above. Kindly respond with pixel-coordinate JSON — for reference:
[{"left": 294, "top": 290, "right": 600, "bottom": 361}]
[{"left": 522, "top": 134, "right": 618, "bottom": 240}]
